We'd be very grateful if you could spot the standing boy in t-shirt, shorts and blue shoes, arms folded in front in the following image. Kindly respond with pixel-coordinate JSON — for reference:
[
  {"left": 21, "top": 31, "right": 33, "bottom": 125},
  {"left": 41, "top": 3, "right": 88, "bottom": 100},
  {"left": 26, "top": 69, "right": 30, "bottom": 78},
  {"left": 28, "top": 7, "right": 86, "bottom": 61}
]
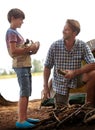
[{"left": 6, "top": 8, "right": 40, "bottom": 128}]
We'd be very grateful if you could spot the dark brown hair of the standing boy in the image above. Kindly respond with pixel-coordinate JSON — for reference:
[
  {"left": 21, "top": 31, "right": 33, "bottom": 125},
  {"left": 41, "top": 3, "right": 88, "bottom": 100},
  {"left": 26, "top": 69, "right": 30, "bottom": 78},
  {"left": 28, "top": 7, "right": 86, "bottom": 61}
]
[{"left": 7, "top": 8, "right": 25, "bottom": 23}]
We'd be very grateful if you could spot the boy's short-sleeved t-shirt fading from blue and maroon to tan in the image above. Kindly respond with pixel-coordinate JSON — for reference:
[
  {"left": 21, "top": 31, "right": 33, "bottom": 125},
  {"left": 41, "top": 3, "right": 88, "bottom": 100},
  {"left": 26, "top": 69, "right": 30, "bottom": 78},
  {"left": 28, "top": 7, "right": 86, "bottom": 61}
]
[{"left": 6, "top": 28, "right": 31, "bottom": 68}]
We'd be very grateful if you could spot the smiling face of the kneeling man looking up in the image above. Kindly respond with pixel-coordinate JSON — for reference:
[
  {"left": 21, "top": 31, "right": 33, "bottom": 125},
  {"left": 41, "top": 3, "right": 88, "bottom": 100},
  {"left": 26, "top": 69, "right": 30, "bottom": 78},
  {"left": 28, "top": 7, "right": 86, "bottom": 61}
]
[{"left": 63, "top": 23, "right": 74, "bottom": 40}]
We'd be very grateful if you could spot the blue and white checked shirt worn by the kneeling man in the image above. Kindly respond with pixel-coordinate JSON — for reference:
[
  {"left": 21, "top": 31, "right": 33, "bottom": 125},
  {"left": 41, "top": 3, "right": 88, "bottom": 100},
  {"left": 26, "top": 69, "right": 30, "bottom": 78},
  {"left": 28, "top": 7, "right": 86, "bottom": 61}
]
[{"left": 45, "top": 39, "right": 95, "bottom": 95}]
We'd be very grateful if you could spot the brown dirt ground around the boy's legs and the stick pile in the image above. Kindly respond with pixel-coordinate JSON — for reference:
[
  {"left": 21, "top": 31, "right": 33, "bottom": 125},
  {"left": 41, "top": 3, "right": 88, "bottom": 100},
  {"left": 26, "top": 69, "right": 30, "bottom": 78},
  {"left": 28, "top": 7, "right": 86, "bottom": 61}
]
[{"left": 0, "top": 99, "right": 95, "bottom": 130}]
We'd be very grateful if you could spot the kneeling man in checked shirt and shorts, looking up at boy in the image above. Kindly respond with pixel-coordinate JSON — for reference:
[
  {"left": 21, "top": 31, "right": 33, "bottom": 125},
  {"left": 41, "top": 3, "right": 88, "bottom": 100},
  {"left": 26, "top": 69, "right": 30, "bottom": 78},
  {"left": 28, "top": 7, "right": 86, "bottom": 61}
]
[{"left": 44, "top": 19, "right": 95, "bottom": 107}]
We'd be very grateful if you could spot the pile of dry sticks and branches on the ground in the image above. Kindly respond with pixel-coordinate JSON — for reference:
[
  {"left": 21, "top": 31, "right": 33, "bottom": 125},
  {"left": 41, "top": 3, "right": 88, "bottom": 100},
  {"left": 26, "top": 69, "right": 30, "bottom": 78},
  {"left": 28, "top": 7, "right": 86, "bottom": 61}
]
[{"left": 31, "top": 104, "right": 95, "bottom": 130}]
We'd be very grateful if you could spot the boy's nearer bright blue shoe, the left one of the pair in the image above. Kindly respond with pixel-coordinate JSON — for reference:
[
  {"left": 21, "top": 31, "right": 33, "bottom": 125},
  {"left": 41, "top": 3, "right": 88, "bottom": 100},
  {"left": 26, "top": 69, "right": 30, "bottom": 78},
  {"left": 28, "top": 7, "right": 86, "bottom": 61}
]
[{"left": 16, "top": 121, "right": 35, "bottom": 128}]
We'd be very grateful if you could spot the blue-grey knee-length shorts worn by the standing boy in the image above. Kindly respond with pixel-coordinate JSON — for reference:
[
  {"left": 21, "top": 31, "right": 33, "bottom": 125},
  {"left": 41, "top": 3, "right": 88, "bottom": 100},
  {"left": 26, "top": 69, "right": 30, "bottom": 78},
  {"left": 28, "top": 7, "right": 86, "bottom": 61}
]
[{"left": 13, "top": 67, "right": 32, "bottom": 97}]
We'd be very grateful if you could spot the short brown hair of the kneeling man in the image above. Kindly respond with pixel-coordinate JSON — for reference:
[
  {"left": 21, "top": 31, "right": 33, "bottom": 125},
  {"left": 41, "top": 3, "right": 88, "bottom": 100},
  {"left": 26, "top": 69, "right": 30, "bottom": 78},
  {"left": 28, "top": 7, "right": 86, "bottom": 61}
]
[{"left": 66, "top": 19, "right": 80, "bottom": 35}]
